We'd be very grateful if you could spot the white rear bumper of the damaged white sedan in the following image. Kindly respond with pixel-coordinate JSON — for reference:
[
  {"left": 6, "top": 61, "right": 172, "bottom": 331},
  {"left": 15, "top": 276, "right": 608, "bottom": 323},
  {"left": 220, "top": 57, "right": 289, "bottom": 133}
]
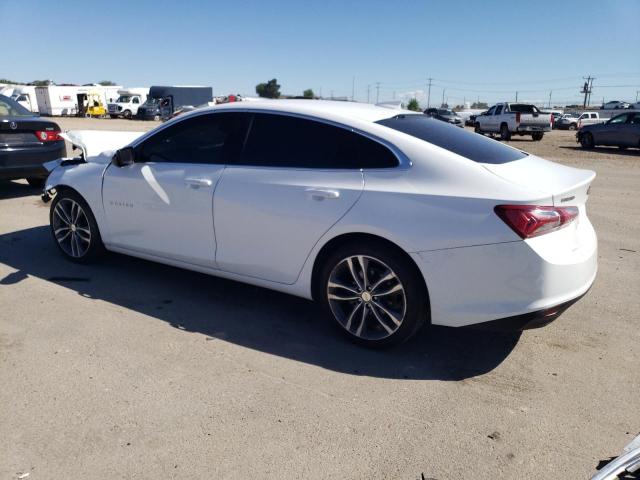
[{"left": 412, "top": 215, "right": 598, "bottom": 330}]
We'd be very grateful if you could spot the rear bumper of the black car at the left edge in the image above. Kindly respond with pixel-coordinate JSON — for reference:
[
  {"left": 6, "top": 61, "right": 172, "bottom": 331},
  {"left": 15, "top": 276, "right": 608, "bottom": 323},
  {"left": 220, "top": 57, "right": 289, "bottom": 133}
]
[{"left": 0, "top": 141, "right": 66, "bottom": 180}]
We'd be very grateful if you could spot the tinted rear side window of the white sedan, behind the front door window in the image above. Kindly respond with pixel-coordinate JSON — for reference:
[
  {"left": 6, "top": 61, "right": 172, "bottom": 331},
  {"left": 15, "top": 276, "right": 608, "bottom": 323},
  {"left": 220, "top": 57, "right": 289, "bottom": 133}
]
[{"left": 240, "top": 113, "right": 398, "bottom": 169}]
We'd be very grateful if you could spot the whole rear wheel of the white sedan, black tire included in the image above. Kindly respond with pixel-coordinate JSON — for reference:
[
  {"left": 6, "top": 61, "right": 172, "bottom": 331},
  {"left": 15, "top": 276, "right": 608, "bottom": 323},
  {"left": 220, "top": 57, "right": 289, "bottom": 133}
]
[{"left": 314, "top": 241, "right": 429, "bottom": 348}]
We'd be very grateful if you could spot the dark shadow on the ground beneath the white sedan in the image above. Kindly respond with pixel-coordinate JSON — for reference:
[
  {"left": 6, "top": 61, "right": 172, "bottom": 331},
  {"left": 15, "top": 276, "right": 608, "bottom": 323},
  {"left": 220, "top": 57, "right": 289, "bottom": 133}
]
[{"left": 0, "top": 226, "right": 520, "bottom": 380}]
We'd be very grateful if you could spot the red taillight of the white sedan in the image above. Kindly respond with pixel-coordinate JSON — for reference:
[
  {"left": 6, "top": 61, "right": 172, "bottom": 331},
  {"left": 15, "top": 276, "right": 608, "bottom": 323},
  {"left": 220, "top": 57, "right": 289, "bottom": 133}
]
[{"left": 494, "top": 205, "right": 578, "bottom": 238}]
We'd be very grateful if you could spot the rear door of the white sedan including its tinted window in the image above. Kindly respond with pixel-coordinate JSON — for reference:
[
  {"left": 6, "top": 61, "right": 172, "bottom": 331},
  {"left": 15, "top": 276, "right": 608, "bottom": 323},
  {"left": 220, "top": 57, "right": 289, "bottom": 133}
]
[{"left": 214, "top": 113, "right": 397, "bottom": 284}]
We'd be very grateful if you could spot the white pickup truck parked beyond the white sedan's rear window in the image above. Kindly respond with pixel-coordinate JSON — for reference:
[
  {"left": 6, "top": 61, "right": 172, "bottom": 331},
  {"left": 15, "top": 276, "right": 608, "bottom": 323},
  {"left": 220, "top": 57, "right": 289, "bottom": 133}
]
[{"left": 475, "top": 103, "right": 553, "bottom": 140}]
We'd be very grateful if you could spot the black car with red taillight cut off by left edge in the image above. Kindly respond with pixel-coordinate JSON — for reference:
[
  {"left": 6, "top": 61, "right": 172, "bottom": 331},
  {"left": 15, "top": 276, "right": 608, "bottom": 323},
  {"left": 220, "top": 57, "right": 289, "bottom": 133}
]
[{"left": 0, "top": 95, "right": 66, "bottom": 187}]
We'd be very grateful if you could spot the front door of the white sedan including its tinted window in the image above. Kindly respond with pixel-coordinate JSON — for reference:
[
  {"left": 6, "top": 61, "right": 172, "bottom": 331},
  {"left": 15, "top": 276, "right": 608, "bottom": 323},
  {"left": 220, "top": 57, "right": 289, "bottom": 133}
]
[{"left": 103, "top": 113, "right": 246, "bottom": 267}]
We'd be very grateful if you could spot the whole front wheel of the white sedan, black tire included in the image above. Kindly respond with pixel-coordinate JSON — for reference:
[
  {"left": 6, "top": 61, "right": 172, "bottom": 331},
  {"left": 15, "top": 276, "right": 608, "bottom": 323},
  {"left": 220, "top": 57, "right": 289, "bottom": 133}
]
[{"left": 49, "top": 190, "right": 106, "bottom": 263}]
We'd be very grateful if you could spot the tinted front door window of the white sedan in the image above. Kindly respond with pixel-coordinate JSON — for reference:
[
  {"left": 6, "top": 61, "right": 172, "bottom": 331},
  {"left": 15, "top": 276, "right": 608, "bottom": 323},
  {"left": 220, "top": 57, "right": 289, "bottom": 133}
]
[{"left": 136, "top": 112, "right": 248, "bottom": 164}]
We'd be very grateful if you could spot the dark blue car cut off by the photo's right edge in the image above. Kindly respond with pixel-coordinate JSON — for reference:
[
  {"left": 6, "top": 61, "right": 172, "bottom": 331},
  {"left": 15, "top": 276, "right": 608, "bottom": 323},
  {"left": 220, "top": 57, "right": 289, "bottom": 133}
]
[{"left": 576, "top": 112, "right": 640, "bottom": 150}]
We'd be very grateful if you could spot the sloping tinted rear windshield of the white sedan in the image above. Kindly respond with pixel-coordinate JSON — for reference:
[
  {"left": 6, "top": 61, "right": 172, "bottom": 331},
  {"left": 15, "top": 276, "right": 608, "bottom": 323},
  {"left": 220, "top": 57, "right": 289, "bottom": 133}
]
[{"left": 377, "top": 115, "right": 527, "bottom": 164}]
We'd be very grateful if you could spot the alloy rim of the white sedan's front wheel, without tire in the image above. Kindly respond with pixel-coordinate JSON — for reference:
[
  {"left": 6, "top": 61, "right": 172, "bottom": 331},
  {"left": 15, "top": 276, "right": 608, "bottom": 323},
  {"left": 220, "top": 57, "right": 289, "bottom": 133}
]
[{"left": 53, "top": 198, "right": 91, "bottom": 258}]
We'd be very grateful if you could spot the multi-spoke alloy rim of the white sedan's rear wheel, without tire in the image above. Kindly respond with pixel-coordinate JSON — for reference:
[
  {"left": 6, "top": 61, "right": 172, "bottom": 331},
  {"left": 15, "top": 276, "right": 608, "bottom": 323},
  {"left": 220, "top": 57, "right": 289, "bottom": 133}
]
[{"left": 327, "top": 255, "right": 407, "bottom": 340}]
